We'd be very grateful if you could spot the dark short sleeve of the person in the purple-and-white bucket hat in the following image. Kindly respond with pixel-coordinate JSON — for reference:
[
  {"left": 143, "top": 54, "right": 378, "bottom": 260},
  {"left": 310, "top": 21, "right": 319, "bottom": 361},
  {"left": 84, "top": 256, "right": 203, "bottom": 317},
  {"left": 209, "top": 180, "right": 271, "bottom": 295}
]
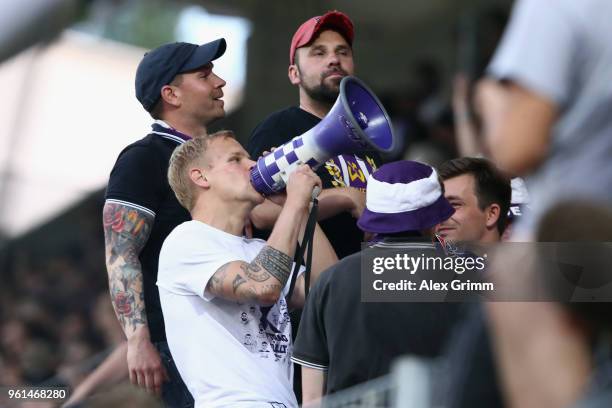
[{"left": 291, "top": 267, "right": 334, "bottom": 370}]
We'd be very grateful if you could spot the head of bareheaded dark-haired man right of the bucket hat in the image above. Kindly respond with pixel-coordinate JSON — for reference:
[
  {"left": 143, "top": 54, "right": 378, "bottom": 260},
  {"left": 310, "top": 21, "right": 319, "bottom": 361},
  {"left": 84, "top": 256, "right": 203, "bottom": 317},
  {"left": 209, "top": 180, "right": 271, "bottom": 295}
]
[{"left": 436, "top": 157, "right": 512, "bottom": 243}]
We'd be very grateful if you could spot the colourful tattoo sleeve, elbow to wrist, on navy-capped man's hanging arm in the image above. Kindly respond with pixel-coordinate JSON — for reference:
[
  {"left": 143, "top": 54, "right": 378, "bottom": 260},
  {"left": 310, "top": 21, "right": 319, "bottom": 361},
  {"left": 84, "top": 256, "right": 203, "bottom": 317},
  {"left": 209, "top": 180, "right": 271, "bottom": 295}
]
[{"left": 103, "top": 203, "right": 154, "bottom": 335}]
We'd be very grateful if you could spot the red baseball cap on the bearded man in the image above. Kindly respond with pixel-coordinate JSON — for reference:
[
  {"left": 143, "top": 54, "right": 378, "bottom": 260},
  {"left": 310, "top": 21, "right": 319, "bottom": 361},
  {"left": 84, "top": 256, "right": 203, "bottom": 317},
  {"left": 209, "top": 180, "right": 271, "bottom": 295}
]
[{"left": 289, "top": 10, "right": 355, "bottom": 64}]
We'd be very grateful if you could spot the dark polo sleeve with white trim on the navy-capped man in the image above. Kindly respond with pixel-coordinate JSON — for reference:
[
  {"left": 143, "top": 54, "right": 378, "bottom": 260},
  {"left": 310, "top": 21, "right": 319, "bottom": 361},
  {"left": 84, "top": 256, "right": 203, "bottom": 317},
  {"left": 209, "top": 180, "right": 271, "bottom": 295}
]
[{"left": 106, "top": 145, "right": 167, "bottom": 215}]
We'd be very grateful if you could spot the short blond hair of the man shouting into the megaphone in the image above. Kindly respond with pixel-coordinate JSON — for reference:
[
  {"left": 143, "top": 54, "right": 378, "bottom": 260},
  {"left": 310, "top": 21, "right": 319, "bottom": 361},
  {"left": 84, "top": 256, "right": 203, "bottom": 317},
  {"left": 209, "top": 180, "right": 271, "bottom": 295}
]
[{"left": 168, "top": 130, "right": 236, "bottom": 211}]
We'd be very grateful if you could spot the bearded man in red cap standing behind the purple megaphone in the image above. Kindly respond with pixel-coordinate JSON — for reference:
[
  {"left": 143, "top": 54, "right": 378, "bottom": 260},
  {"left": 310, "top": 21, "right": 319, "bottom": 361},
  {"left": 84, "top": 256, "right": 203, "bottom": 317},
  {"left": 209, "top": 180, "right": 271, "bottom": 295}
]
[{"left": 247, "top": 11, "right": 380, "bottom": 258}]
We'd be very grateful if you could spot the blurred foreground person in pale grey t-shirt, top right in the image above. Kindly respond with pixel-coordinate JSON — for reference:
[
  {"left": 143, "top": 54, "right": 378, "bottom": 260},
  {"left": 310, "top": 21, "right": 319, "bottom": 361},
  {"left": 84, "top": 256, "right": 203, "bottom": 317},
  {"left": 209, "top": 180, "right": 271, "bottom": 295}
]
[{"left": 478, "top": 0, "right": 612, "bottom": 236}]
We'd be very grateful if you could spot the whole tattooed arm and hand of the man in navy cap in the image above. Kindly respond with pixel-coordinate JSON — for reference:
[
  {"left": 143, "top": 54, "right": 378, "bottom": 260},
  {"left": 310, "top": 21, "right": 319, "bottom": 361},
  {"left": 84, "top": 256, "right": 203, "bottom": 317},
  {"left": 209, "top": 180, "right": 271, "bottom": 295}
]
[{"left": 103, "top": 202, "right": 166, "bottom": 394}]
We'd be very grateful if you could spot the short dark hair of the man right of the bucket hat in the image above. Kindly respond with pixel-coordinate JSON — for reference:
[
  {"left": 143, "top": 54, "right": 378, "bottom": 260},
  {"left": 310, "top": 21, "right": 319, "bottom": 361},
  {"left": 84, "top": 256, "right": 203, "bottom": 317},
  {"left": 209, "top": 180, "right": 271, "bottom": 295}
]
[{"left": 438, "top": 157, "right": 512, "bottom": 234}]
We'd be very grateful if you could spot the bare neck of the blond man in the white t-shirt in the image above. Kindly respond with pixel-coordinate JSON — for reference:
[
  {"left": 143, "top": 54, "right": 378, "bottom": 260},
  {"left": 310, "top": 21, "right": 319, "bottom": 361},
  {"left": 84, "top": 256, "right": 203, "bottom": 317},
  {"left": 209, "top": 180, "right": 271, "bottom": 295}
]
[{"left": 191, "top": 200, "right": 253, "bottom": 236}]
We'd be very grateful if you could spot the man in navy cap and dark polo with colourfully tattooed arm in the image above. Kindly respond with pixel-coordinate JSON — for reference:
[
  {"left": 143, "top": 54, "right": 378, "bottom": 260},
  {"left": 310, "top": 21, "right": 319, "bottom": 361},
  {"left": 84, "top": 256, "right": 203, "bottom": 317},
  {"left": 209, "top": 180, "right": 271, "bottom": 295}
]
[{"left": 104, "top": 39, "right": 226, "bottom": 407}]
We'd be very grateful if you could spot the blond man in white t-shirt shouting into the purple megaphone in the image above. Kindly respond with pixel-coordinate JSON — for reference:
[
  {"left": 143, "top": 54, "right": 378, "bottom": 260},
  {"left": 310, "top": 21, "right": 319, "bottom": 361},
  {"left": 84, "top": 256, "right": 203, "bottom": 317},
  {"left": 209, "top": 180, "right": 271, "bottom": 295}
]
[{"left": 157, "top": 131, "right": 337, "bottom": 408}]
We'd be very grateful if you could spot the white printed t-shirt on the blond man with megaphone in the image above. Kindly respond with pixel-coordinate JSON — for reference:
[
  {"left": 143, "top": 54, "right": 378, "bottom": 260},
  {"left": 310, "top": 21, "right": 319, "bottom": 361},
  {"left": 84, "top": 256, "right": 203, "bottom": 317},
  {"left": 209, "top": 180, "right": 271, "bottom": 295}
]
[{"left": 157, "top": 221, "right": 298, "bottom": 408}]
